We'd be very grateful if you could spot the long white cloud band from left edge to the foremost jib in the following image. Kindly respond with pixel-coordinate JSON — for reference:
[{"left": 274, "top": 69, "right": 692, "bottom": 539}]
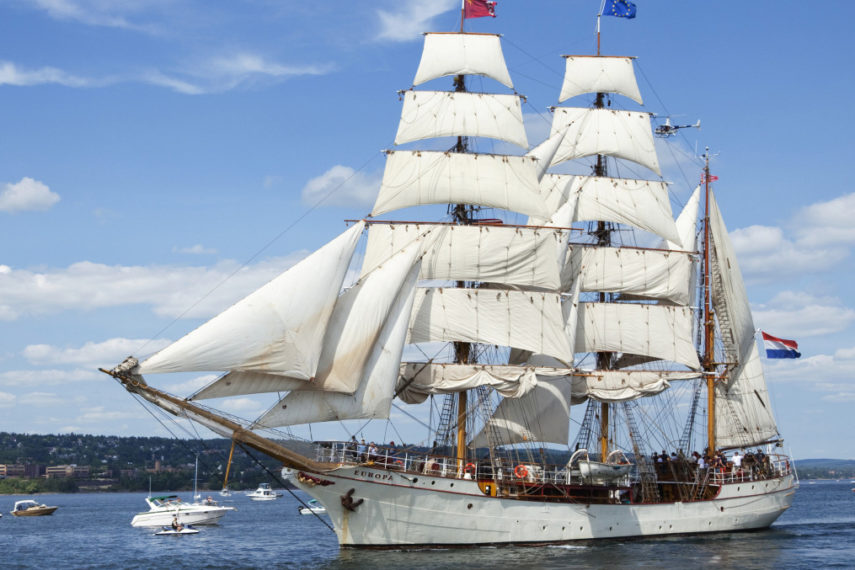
[{"left": 0, "top": 253, "right": 305, "bottom": 321}]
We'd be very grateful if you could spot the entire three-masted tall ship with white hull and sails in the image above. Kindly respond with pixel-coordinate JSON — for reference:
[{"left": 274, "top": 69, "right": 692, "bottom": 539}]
[{"left": 104, "top": 4, "right": 798, "bottom": 548}]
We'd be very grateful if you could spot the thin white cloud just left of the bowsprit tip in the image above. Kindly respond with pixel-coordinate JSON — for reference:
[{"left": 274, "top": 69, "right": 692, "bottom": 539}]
[{"left": 23, "top": 338, "right": 171, "bottom": 368}]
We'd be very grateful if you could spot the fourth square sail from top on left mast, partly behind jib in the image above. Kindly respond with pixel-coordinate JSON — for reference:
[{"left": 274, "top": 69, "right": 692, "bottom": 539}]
[{"left": 362, "top": 224, "right": 566, "bottom": 291}]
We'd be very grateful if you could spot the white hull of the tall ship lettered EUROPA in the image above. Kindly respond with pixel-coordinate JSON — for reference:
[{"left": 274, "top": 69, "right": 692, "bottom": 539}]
[{"left": 291, "top": 467, "right": 795, "bottom": 547}]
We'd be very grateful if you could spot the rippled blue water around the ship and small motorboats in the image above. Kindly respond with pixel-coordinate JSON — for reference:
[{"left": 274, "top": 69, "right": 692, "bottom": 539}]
[{"left": 0, "top": 481, "right": 855, "bottom": 569}]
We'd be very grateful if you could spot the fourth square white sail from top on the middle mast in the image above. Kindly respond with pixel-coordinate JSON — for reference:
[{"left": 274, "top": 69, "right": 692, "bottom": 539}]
[{"left": 561, "top": 244, "right": 693, "bottom": 305}]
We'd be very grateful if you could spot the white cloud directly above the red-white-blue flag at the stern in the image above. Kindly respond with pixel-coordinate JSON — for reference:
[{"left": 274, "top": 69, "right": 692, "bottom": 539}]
[{"left": 753, "top": 291, "right": 855, "bottom": 338}]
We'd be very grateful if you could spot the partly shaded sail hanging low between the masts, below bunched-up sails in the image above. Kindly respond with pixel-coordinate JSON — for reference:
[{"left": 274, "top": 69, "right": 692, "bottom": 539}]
[{"left": 469, "top": 376, "right": 585, "bottom": 448}]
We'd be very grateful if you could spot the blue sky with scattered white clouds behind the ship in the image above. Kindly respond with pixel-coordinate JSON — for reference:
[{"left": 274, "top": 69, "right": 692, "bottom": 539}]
[{"left": 0, "top": 0, "right": 855, "bottom": 458}]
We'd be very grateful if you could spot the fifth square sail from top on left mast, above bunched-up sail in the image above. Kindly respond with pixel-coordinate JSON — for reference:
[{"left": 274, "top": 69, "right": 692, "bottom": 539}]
[{"left": 408, "top": 288, "right": 573, "bottom": 363}]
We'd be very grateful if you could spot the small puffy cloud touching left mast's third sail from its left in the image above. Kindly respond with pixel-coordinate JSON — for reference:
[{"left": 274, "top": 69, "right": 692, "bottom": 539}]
[{"left": 302, "top": 165, "right": 383, "bottom": 208}]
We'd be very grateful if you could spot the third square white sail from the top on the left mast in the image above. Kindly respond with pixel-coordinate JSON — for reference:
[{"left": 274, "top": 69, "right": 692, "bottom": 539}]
[{"left": 371, "top": 151, "right": 547, "bottom": 216}]
